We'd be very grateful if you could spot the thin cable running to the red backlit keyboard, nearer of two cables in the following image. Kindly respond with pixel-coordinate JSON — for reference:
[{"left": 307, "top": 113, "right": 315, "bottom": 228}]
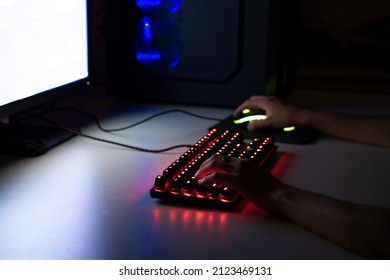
[{"left": 25, "top": 114, "right": 193, "bottom": 154}]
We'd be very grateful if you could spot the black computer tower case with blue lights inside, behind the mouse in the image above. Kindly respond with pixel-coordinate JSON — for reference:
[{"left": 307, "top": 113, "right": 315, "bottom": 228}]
[{"left": 105, "top": 0, "right": 298, "bottom": 107}]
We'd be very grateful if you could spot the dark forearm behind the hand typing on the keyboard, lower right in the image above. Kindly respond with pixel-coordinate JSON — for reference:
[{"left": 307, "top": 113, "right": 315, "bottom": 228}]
[{"left": 274, "top": 186, "right": 390, "bottom": 258}]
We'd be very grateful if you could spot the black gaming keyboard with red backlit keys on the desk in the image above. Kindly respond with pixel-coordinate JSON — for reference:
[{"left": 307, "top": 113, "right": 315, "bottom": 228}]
[{"left": 150, "top": 129, "right": 277, "bottom": 205}]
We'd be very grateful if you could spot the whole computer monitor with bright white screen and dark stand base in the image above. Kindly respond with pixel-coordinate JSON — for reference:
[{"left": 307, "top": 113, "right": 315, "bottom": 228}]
[{"left": 0, "top": 0, "right": 90, "bottom": 155}]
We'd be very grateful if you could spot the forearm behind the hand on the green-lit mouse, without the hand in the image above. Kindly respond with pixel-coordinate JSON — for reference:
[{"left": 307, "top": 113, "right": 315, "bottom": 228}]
[{"left": 292, "top": 107, "right": 390, "bottom": 147}]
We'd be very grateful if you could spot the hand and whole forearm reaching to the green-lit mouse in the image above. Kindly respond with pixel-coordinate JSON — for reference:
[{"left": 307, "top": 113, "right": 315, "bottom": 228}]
[{"left": 234, "top": 96, "right": 390, "bottom": 147}]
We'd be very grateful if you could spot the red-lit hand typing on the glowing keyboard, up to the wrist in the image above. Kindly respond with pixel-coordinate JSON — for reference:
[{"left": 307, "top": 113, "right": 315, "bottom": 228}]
[{"left": 195, "top": 155, "right": 285, "bottom": 212}]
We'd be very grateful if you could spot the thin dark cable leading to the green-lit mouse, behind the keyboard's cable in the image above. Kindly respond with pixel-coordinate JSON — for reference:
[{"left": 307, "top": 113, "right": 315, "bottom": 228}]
[{"left": 45, "top": 107, "right": 222, "bottom": 132}]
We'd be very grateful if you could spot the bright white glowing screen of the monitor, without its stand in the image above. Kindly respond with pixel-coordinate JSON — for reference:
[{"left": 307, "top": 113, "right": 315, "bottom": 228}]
[{"left": 0, "top": 0, "right": 88, "bottom": 117}]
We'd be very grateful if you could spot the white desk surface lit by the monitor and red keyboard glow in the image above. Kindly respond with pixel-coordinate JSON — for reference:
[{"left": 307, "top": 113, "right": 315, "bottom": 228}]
[{"left": 0, "top": 93, "right": 390, "bottom": 259}]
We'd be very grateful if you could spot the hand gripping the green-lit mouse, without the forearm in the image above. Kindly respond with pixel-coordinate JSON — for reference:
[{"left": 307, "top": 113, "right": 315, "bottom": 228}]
[{"left": 233, "top": 96, "right": 298, "bottom": 131}]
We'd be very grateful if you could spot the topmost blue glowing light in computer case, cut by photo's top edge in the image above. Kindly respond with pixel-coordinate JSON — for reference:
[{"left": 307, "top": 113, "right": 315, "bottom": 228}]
[{"left": 135, "top": 0, "right": 182, "bottom": 14}]
